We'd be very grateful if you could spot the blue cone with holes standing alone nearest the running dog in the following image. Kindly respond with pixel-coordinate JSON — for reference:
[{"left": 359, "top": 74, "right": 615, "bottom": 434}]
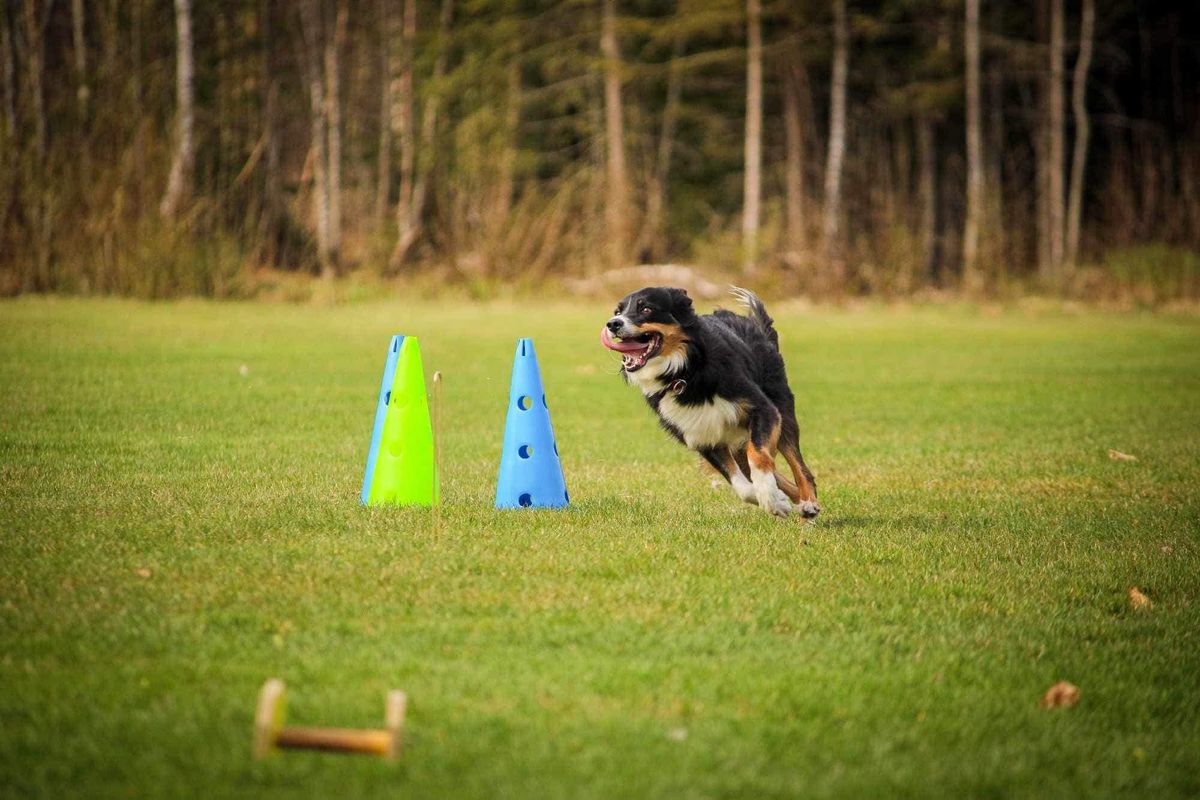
[{"left": 496, "top": 339, "right": 570, "bottom": 509}]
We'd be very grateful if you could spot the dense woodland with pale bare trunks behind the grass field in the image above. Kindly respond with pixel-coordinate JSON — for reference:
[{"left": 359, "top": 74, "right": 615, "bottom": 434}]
[{"left": 0, "top": 0, "right": 1200, "bottom": 302}]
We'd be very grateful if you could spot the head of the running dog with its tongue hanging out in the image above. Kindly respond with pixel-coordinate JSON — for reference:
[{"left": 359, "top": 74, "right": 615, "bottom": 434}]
[{"left": 600, "top": 287, "right": 696, "bottom": 373}]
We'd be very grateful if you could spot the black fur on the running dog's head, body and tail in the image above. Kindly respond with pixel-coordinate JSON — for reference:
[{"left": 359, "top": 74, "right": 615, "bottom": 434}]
[{"left": 604, "top": 287, "right": 816, "bottom": 516}]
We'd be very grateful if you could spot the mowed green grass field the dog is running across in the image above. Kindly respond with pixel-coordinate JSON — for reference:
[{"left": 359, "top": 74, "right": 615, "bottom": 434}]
[{"left": 0, "top": 300, "right": 1200, "bottom": 798}]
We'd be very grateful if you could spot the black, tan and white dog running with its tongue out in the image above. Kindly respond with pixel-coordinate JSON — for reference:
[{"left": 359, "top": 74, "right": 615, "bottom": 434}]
[{"left": 600, "top": 288, "right": 821, "bottom": 519}]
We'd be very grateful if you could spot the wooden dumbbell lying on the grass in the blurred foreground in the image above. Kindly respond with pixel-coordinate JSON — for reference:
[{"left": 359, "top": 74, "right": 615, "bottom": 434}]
[{"left": 254, "top": 678, "right": 408, "bottom": 760}]
